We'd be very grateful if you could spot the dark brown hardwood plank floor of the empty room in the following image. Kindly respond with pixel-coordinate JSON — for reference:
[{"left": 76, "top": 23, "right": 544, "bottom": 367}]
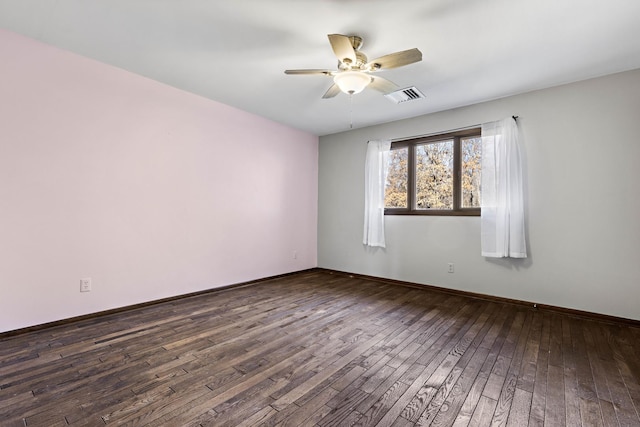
[{"left": 0, "top": 271, "right": 640, "bottom": 427}]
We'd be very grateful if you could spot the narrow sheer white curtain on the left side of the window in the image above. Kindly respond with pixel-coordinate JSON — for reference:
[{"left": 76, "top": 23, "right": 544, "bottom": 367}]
[{"left": 362, "top": 141, "right": 391, "bottom": 248}]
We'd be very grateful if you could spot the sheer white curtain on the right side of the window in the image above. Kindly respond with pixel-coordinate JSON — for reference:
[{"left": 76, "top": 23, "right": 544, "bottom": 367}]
[{"left": 481, "top": 117, "right": 527, "bottom": 258}]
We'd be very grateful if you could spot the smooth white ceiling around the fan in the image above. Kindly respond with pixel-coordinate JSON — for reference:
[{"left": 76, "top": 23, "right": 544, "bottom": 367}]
[{"left": 0, "top": 0, "right": 640, "bottom": 135}]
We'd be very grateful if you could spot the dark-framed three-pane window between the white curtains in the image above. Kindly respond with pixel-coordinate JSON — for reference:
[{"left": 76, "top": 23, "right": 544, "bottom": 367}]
[{"left": 385, "top": 128, "right": 482, "bottom": 216}]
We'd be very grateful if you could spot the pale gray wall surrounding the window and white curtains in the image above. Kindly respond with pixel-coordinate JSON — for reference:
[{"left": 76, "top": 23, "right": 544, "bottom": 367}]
[{"left": 318, "top": 70, "right": 640, "bottom": 319}]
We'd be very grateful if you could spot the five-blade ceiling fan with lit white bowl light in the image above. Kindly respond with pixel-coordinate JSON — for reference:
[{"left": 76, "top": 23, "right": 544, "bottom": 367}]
[{"left": 285, "top": 34, "right": 422, "bottom": 99}]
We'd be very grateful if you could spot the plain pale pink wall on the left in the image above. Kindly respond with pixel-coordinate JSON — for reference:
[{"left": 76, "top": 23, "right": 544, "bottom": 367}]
[{"left": 0, "top": 30, "right": 318, "bottom": 332}]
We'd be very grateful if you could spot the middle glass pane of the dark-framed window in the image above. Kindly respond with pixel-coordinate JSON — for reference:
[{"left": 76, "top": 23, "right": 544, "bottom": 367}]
[{"left": 416, "top": 140, "right": 453, "bottom": 209}]
